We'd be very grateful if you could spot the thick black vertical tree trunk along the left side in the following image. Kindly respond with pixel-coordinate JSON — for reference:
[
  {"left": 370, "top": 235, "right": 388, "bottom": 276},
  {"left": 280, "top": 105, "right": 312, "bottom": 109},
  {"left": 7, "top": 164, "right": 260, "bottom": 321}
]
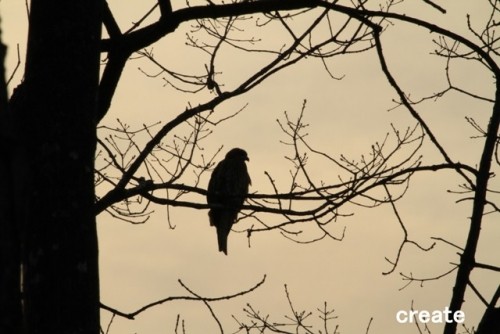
[{"left": 0, "top": 0, "right": 102, "bottom": 334}]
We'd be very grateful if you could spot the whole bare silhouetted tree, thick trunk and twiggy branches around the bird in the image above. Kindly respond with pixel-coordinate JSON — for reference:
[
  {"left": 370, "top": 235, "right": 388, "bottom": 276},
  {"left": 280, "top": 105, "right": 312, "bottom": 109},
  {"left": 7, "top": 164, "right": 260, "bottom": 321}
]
[{"left": 0, "top": 0, "right": 500, "bottom": 334}]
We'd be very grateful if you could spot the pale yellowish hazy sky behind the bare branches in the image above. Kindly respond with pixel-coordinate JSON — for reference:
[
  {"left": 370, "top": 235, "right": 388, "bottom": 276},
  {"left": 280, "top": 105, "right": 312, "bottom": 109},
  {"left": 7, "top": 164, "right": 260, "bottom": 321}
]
[{"left": 0, "top": 0, "right": 500, "bottom": 334}]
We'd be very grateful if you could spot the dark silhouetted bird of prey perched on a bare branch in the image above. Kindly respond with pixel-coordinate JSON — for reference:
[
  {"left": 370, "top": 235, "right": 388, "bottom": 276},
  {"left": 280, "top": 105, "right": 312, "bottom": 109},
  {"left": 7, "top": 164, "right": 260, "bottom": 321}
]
[{"left": 207, "top": 148, "right": 251, "bottom": 255}]
